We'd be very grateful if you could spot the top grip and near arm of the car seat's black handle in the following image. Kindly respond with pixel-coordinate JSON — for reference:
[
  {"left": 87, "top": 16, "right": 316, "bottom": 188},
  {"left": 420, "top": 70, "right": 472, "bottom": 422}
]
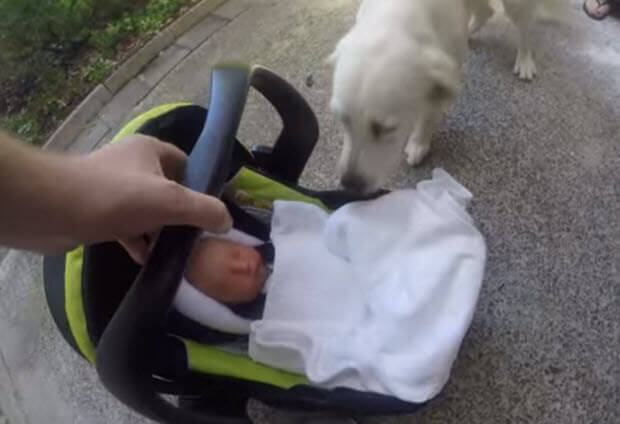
[{"left": 96, "top": 65, "right": 253, "bottom": 424}]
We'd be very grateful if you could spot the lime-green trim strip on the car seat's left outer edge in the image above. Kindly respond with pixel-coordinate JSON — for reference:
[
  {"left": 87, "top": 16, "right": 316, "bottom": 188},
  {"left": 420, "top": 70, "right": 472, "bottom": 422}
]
[{"left": 65, "top": 246, "right": 95, "bottom": 363}]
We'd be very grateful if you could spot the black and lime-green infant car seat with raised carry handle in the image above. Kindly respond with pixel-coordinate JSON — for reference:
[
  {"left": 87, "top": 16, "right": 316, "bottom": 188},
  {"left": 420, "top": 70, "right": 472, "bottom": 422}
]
[{"left": 44, "top": 65, "right": 422, "bottom": 424}]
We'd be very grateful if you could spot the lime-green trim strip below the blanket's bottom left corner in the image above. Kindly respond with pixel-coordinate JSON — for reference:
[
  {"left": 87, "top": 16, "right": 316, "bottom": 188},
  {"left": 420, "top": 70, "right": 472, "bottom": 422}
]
[{"left": 183, "top": 340, "right": 308, "bottom": 389}]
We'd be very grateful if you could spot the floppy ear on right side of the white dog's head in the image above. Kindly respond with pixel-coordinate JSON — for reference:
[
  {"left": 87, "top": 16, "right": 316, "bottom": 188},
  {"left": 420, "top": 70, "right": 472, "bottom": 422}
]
[{"left": 424, "top": 48, "right": 461, "bottom": 103}]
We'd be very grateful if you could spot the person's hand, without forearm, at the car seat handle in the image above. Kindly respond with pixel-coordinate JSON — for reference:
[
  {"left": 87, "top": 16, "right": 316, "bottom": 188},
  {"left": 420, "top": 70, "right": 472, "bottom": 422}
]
[{"left": 76, "top": 135, "right": 232, "bottom": 264}]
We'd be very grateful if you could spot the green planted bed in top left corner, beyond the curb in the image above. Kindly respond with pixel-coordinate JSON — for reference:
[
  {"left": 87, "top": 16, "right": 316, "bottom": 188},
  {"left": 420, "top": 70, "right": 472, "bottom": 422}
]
[{"left": 0, "top": 0, "right": 191, "bottom": 142}]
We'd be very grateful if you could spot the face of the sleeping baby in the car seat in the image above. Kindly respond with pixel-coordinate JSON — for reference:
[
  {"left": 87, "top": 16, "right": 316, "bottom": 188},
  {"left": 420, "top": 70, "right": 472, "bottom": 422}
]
[{"left": 185, "top": 239, "right": 267, "bottom": 304}]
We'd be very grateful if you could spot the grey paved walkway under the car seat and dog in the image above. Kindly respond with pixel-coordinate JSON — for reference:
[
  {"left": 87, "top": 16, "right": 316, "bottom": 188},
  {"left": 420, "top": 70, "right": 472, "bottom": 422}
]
[{"left": 0, "top": 0, "right": 620, "bottom": 424}]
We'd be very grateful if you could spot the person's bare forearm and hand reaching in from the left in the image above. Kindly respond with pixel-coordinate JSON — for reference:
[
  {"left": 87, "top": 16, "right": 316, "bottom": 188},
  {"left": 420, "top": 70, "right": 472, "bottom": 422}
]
[{"left": 0, "top": 134, "right": 232, "bottom": 262}]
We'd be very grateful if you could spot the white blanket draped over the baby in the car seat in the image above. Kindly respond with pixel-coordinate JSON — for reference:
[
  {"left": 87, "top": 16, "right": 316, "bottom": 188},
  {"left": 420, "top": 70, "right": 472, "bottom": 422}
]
[{"left": 250, "top": 170, "right": 486, "bottom": 402}]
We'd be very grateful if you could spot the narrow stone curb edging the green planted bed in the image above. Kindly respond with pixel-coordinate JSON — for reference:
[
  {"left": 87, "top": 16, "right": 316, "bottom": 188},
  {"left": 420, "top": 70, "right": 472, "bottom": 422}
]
[{"left": 43, "top": 0, "right": 228, "bottom": 151}]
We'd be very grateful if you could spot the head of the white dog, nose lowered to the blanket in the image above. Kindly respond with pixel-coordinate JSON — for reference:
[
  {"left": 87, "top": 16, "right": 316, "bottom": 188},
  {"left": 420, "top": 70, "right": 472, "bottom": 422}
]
[{"left": 330, "top": 32, "right": 459, "bottom": 193}]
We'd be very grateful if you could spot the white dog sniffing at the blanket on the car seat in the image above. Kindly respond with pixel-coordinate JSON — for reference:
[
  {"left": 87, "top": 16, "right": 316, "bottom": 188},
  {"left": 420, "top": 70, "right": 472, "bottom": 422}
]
[{"left": 331, "top": 0, "right": 567, "bottom": 192}]
